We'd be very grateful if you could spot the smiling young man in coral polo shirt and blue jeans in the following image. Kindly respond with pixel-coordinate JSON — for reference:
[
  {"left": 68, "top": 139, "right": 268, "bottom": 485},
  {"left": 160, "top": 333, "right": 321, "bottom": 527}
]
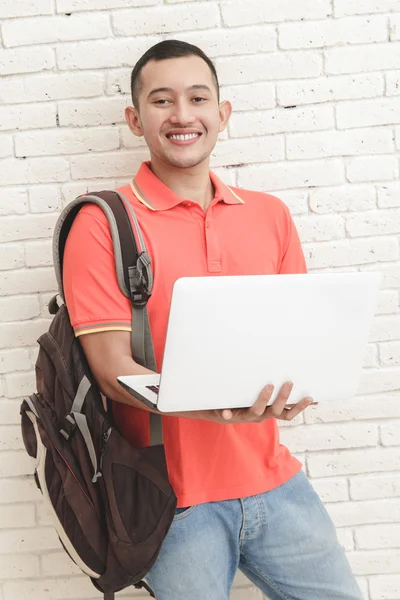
[{"left": 64, "top": 40, "right": 362, "bottom": 600}]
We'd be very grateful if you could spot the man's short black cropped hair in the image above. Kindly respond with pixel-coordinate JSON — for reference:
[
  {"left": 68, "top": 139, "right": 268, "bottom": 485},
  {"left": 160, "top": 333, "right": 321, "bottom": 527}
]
[{"left": 131, "top": 40, "right": 219, "bottom": 108}]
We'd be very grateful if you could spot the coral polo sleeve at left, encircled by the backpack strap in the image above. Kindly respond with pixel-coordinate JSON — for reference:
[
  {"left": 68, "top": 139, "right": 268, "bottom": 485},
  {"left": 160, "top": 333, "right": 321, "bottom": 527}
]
[{"left": 63, "top": 205, "right": 132, "bottom": 336}]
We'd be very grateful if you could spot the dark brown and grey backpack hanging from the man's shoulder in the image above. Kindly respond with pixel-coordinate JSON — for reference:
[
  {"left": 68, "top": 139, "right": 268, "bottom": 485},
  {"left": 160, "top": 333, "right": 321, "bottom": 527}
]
[{"left": 21, "top": 191, "right": 176, "bottom": 600}]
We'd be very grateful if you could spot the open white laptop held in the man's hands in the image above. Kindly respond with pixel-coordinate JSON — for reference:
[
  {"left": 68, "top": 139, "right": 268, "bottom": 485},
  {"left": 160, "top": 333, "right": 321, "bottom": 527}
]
[{"left": 118, "top": 273, "right": 381, "bottom": 412}]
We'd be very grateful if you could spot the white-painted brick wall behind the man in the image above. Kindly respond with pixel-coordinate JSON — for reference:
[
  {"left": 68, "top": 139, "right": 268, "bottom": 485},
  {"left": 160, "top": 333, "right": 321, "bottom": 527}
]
[{"left": 0, "top": 0, "right": 400, "bottom": 600}]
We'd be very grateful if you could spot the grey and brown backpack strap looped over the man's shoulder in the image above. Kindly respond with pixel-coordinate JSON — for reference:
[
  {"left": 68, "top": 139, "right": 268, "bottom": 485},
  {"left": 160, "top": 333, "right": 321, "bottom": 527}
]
[{"left": 53, "top": 191, "right": 162, "bottom": 444}]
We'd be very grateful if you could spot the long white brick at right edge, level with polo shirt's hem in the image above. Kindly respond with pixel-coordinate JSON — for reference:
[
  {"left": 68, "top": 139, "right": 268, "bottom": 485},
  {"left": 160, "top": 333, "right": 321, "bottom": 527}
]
[{"left": 307, "top": 448, "right": 400, "bottom": 476}]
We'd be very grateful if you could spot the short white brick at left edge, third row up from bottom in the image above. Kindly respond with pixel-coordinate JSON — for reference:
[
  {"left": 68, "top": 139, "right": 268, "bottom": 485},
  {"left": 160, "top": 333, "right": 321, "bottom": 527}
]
[{"left": 0, "top": 527, "right": 60, "bottom": 554}]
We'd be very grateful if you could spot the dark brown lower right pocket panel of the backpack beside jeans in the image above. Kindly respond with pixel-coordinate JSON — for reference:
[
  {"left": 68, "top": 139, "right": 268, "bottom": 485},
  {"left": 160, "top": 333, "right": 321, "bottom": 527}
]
[{"left": 102, "top": 429, "right": 176, "bottom": 580}]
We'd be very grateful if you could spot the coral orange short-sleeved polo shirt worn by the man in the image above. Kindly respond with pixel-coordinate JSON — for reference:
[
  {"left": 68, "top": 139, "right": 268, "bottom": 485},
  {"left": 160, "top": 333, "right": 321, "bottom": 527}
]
[{"left": 64, "top": 163, "right": 306, "bottom": 507}]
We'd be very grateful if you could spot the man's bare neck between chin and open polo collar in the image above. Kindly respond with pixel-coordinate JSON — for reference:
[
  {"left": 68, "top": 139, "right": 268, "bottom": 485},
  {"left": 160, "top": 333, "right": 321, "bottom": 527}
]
[{"left": 150, "top": 157, "right": 214, "bottom": 211}]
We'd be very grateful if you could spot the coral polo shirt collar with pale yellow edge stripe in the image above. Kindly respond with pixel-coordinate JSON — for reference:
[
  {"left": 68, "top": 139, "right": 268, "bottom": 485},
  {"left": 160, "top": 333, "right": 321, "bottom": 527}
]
[{"left": 130, "top": 162, "right": 244, "bottom": 211}]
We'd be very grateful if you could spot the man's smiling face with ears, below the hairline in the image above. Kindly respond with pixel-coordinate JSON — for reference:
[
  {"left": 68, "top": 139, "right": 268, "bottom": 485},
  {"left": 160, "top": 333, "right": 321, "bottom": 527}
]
[{"left": 126, "top": 56, "right": 231, "bottom": 169}]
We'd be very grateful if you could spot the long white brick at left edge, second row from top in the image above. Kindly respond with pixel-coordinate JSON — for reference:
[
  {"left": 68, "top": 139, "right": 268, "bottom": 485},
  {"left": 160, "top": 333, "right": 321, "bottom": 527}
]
[{"left": 2, "top": 13, "right": 111, "bottom": 47}]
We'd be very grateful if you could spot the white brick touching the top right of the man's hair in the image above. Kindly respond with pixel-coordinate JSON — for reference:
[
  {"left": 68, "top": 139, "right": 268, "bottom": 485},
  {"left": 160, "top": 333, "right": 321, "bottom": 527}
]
[{"left": 179, "top": 25, "right": 277, "bottom": 59}]
